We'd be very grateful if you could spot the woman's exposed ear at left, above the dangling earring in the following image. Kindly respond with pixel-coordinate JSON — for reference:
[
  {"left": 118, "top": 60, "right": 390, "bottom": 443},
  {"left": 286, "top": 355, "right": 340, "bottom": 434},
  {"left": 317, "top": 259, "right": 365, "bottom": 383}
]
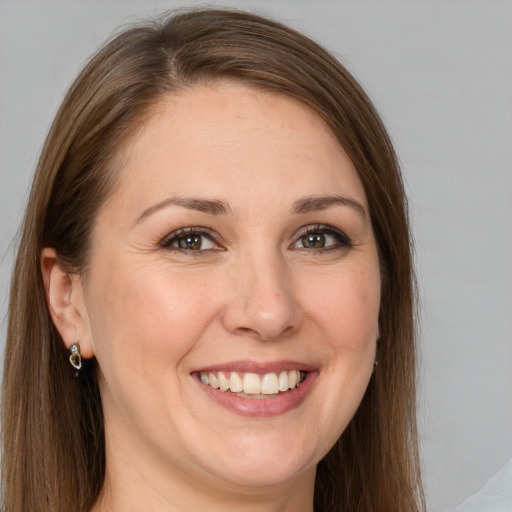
[{"left": 41, "top": 247, "right": 94, "bottom": 358}]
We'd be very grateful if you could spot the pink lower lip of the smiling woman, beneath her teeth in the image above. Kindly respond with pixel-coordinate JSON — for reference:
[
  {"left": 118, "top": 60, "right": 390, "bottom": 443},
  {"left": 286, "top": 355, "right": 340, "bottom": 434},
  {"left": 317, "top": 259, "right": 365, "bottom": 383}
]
[{"left": 195, "top": 371, "right": 318, "bottom": 418}]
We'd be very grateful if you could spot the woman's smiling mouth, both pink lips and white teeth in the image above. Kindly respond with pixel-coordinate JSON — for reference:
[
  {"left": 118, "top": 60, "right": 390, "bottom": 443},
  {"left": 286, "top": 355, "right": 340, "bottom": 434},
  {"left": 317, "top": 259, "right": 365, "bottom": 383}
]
[{"left": 191, "top": 362, "right": 319, "bottom": 418}]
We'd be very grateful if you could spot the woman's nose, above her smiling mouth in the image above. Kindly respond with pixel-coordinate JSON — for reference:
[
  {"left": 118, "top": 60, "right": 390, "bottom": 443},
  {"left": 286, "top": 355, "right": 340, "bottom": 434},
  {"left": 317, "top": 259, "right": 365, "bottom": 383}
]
[{"left": 223, "top": 251, "right": 302, "bottom": 341}]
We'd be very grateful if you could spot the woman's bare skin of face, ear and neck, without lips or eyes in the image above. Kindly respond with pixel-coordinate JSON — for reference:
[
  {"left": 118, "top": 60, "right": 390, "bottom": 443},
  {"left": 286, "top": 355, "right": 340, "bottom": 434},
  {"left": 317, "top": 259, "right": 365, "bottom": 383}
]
[{"left": 42, "top": 83, "right": 380, "bottom": 512}]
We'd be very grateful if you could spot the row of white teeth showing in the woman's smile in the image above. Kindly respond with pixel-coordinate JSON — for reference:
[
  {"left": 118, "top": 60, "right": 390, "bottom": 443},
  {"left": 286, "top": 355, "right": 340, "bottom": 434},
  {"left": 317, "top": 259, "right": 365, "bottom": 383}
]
[{"left": 200, "top": 370, "right": 306, "bottom": 395}]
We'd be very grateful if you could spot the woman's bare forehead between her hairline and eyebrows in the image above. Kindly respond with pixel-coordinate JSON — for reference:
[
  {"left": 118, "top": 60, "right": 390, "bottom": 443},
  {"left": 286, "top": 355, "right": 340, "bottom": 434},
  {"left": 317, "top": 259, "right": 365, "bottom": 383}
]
[{"left": 111, "top": 83, "right": 366, "bottom": 212}]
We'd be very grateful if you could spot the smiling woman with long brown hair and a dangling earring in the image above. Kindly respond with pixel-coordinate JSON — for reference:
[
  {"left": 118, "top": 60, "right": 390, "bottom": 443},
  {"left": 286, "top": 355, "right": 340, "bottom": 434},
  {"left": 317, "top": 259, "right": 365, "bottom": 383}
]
[{"left": 3, "top": 10, "right": 422, "bottom": 512}]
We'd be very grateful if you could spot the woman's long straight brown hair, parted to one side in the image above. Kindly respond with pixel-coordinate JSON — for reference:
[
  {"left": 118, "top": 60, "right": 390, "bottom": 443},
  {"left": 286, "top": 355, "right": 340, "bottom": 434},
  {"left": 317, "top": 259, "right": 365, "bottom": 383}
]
[{"left": 2, "top": 9, "right": 424, "bottom": 512}]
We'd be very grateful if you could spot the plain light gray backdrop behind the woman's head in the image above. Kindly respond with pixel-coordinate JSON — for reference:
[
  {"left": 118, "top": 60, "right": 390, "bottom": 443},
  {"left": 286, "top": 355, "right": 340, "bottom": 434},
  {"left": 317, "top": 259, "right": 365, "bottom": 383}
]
[{"left": 0, "top": 0, "right": 512, "bottom": 511}]
